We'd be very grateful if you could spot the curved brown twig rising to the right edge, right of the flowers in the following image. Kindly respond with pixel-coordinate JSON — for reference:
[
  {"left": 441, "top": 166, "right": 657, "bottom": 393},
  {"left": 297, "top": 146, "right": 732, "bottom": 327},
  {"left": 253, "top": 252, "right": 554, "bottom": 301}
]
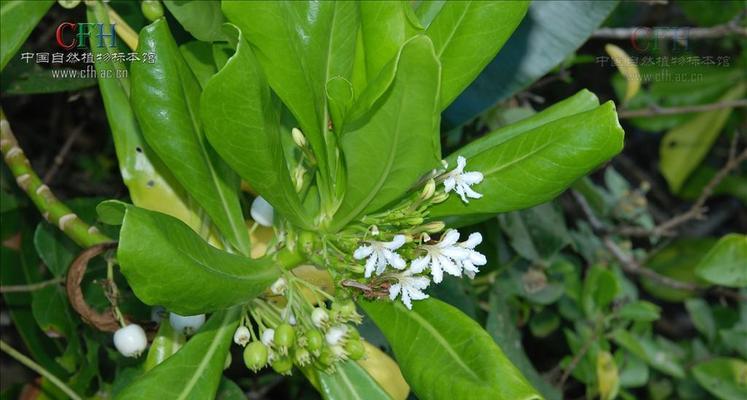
[{"left": 615, "top": 143, "right": 747, "bottom": 237}]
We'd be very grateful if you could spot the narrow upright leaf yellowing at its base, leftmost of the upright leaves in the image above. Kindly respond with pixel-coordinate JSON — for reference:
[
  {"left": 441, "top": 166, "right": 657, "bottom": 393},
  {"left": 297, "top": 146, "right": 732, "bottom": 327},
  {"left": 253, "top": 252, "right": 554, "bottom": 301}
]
[{"left": 87, "top": 3, "right": 202, "bottom": 231}]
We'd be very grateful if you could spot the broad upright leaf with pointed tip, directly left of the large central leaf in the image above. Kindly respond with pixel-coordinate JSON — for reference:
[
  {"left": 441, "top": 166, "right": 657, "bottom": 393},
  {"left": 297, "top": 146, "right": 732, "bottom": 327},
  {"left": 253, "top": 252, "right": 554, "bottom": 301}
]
[{"left": 201, "top": 27, "right": 311, "bottom": 229}]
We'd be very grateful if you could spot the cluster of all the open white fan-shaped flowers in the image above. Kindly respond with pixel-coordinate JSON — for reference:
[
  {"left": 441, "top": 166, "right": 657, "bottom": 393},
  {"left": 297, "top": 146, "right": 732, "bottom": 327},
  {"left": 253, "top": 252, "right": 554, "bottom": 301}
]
[{"left": 353, "top": 156, "right": 487, "bottom": 309}]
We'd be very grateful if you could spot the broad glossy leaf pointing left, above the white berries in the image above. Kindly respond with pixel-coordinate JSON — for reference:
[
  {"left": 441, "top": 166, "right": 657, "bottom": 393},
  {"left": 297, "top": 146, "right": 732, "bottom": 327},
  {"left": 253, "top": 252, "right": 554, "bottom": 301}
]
[{"left": 117, "top": 207, "right": 280, "bottom": 315}]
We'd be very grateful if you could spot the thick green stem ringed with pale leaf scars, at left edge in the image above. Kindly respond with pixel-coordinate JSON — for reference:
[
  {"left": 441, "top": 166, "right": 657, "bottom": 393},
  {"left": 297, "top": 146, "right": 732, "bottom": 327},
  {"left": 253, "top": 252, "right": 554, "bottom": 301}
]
[{"left": 0, "top": 108, "right": 112, "bottom": 248}]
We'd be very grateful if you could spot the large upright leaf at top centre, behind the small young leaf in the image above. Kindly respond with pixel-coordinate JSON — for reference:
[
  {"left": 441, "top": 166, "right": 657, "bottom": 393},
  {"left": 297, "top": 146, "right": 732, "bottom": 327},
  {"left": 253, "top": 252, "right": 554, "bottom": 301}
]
[{"left": 223, "top": 0, "right": 359, "bottom": 196}]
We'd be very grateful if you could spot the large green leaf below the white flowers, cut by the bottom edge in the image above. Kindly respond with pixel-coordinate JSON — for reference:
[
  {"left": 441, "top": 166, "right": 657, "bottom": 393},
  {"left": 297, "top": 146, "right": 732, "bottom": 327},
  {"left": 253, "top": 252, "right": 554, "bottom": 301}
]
[{"left": 360, "top": 298, "right": 541, "bottom": 400}]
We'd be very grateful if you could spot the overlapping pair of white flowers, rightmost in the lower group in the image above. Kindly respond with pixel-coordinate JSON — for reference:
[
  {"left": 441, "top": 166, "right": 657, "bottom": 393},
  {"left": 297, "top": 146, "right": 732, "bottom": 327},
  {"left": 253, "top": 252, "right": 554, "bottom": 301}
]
[{"left": 410, "top": 229, "right": 487, "bottom": 283}]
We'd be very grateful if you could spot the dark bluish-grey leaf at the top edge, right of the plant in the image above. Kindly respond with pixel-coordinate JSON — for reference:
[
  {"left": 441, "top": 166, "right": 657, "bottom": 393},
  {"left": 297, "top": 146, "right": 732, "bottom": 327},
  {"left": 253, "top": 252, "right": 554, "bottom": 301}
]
[{"left": 444, "top": 1, "right": 618, "bottom": 127}]
